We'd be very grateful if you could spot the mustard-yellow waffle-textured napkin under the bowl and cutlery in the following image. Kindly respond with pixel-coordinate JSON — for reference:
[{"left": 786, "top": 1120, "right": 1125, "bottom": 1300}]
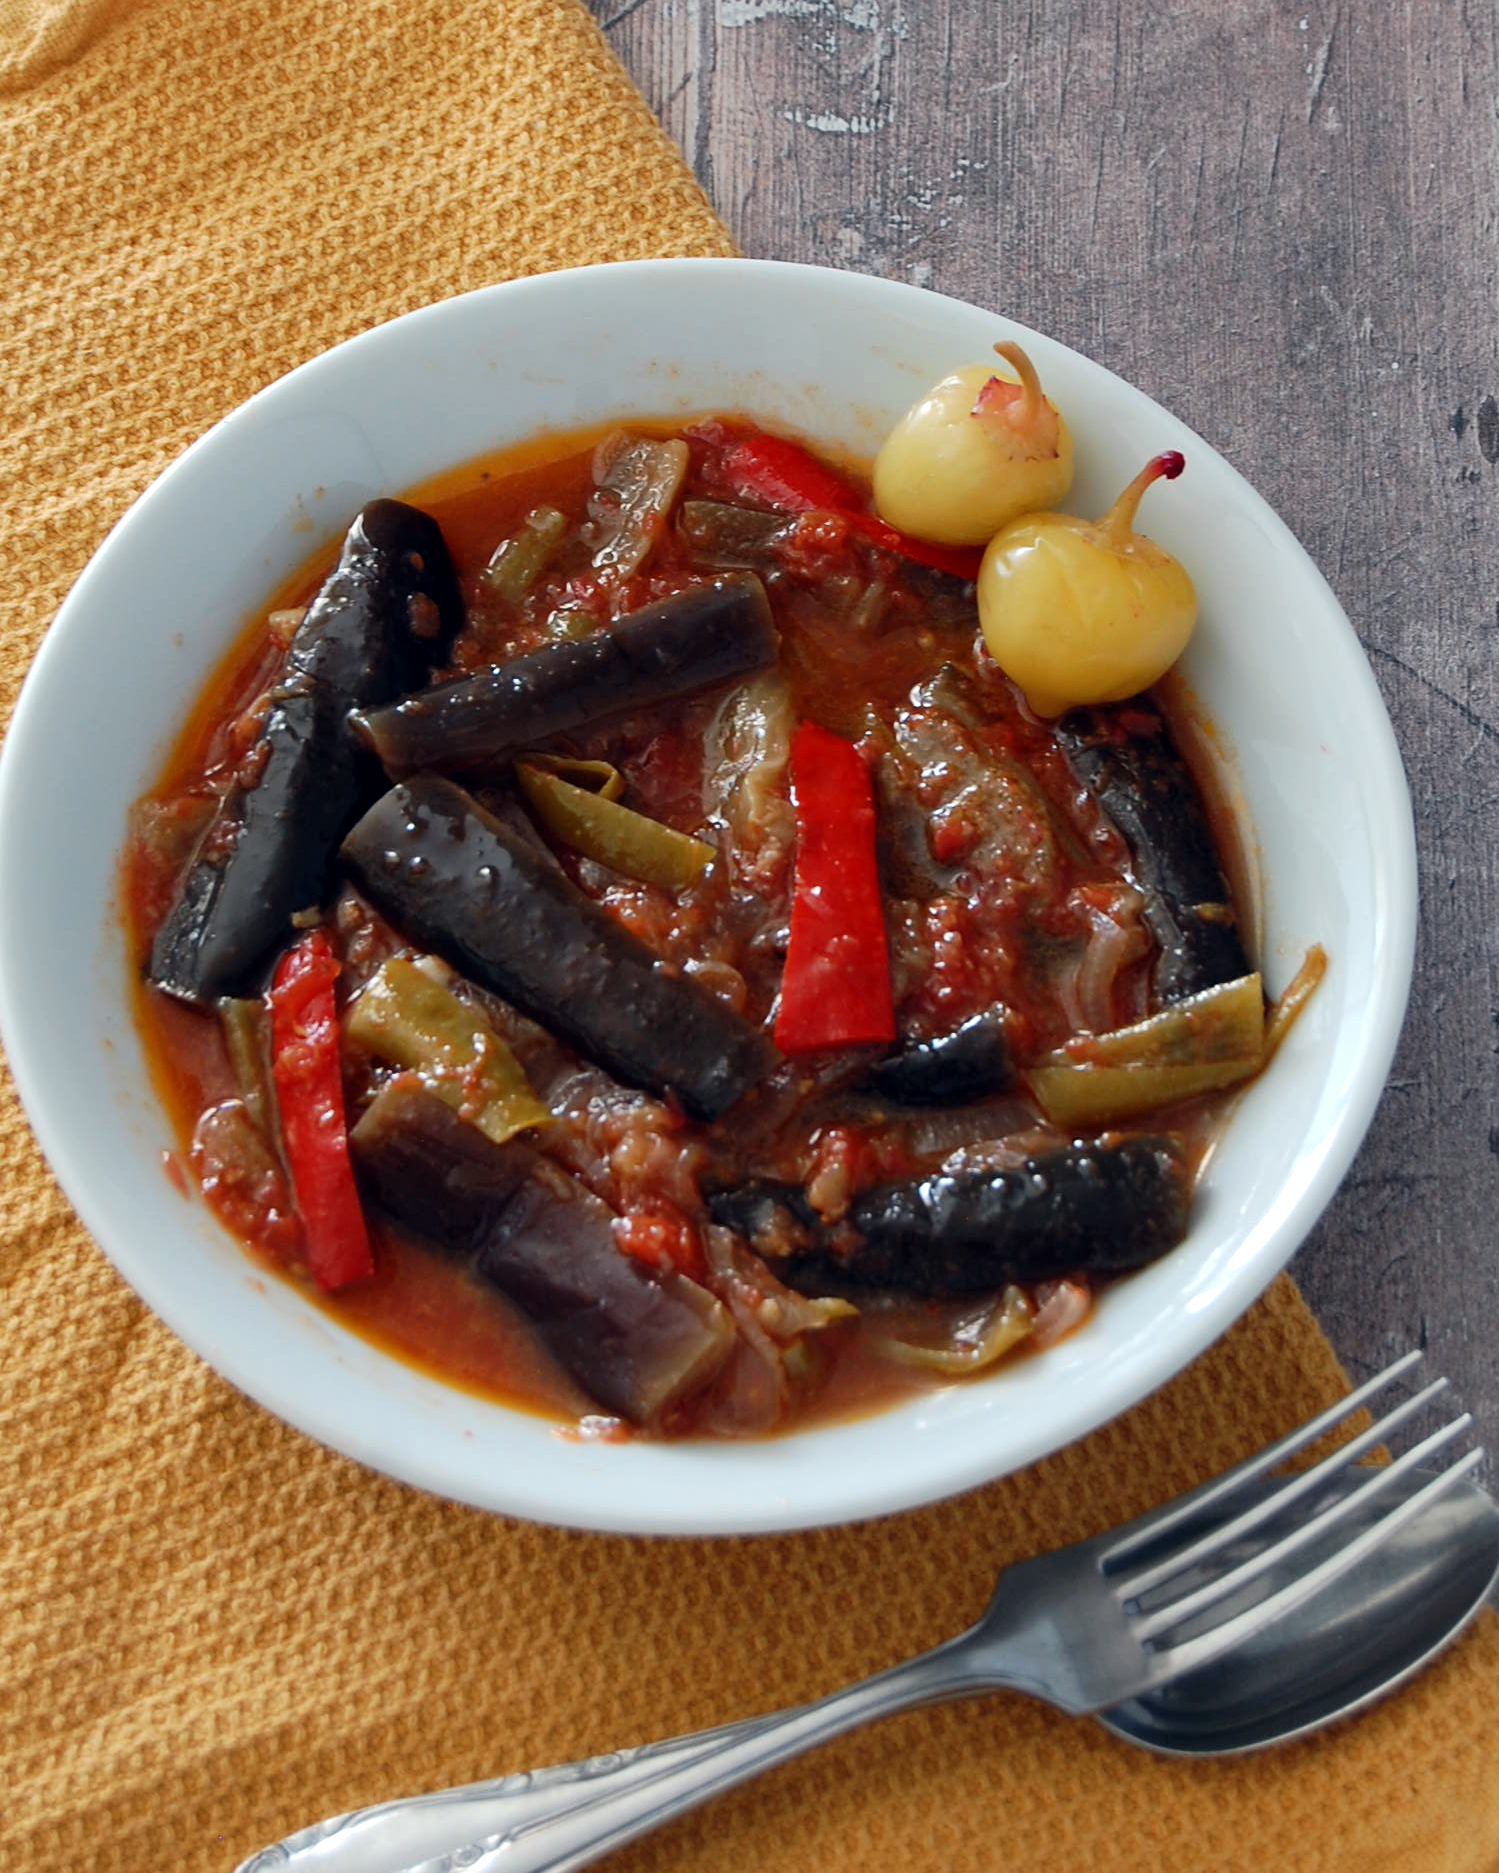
[{"left": 0, "top": 0, "right": 1499, "bottom": 1873}]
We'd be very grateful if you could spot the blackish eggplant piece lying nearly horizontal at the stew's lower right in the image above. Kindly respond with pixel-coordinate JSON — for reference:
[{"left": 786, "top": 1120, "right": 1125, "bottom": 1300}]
[{"left": 708, "top": 1137, "right": 1192, "bottom": 1300}]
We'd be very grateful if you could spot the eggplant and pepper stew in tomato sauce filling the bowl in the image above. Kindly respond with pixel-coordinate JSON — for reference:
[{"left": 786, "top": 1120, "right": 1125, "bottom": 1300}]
[{"left": 126, "top": 418, "right": 1304, "bottom": 1437}]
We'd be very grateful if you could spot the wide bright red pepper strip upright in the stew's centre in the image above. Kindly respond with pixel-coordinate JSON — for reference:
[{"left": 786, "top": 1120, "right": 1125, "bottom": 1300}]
[{"left": 776, "top": 721, "right": 896, "bottom": 1054}]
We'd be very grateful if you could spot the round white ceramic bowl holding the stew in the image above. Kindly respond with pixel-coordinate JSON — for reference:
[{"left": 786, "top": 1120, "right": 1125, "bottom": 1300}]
[{"left": 0, "top": 260, "right": 1415, "bottom": 1534}]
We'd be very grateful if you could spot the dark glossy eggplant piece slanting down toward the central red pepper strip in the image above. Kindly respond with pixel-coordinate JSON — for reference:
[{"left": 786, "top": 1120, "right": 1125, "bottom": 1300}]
[{"left": 343, "top": 774, "right": 776, "bottom": 1118}]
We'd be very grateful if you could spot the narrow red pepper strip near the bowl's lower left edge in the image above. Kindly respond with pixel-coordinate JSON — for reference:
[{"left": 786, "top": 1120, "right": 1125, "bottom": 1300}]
[{"left": 270, "top": 931, "right": 375, "bottom": 1289}]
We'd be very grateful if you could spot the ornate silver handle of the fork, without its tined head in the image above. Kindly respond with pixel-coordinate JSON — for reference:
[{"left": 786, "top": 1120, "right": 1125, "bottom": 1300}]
[{"left": 236, "top": 1633, "right": 993, "bottom": 1873}]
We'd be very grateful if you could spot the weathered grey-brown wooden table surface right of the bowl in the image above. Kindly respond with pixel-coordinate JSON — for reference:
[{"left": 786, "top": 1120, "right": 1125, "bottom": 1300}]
[{"left": 590, "top": 0, "right": 1499, "bottom": 1452}]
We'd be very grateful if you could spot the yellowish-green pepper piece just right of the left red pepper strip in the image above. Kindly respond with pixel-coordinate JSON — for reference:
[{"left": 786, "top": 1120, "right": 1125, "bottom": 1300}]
[{"left": 349, "top": 955, "right": 551, "bottom": 1144}]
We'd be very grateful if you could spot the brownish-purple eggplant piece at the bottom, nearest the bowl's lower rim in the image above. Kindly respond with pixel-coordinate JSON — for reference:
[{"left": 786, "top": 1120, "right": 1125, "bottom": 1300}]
[{"left": 350, "top": 1077, "right": 735, "bottom": 1423}]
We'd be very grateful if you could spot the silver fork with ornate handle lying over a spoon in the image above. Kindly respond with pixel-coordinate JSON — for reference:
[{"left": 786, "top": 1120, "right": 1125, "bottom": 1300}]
[{"left": 236, "top": 1352, "right": 1484, "bottom": 1873}]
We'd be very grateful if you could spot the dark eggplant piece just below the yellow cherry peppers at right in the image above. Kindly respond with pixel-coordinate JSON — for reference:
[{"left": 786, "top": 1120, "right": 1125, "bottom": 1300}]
[{"left": 1057, "top": 702, "right": 1250, "bottom": 1002}]
